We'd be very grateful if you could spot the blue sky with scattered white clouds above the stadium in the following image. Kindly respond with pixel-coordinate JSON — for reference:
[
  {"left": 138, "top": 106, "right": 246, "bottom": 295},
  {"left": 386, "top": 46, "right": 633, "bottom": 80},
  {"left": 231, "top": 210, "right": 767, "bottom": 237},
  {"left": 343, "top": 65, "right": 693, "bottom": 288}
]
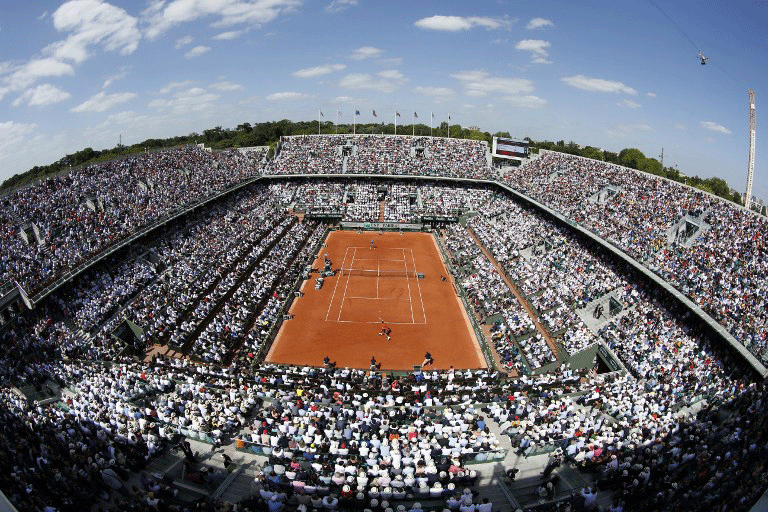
[{"left": 0, "top": 0, "right": 768, "bottom": 199}]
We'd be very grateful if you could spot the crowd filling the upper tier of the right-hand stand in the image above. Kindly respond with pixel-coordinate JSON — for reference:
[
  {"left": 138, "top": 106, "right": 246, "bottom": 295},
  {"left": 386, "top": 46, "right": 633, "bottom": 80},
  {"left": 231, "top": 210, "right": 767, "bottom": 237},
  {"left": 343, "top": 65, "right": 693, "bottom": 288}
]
[{"left": 505, "top": 152, "right": 768, "bottom": 363}]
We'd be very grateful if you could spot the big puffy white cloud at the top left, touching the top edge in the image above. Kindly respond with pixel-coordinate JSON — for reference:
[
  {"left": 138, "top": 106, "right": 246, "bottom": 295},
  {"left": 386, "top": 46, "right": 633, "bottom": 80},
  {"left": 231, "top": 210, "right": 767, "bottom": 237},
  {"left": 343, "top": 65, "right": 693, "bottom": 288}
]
[{"left": 43, "top": 0, "right": 141, "bottom": 63}]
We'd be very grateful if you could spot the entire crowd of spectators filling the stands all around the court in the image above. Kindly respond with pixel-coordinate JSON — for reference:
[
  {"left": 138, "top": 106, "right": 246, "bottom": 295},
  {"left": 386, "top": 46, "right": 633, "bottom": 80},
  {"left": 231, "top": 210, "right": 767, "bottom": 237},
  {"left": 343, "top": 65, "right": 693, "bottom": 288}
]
[{"left": 0, "top": 140, "right": 768, "bottom": 512}]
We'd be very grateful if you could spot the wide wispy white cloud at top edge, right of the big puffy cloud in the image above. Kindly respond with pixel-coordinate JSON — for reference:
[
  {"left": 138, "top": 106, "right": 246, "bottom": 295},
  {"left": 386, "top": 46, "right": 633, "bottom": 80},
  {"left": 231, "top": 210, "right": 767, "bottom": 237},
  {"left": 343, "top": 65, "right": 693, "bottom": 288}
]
[{"left": 143, "top": 0, "right": 301, "bottom": 39}]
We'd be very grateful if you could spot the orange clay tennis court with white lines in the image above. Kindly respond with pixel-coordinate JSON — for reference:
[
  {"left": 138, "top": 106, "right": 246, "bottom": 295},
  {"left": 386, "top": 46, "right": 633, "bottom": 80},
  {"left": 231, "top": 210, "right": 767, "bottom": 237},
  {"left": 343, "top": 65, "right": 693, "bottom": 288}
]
[{"left": 266, "top": 231, "right": 486, "bottom": 370}]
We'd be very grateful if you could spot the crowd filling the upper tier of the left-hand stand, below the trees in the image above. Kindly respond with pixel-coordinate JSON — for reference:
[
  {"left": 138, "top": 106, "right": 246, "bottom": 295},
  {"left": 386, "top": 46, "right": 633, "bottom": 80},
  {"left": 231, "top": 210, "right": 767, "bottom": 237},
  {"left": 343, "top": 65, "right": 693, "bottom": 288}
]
[{"left": 0, "top": 146, "right": 266, "bottom": 294}]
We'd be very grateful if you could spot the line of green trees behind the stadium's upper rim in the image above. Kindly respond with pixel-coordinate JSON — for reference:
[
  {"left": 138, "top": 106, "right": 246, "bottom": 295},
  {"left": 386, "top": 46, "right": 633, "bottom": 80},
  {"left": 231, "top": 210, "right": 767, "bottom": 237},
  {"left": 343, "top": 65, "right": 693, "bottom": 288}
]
[{"left": 0, "top": 119, "right": 765, "bottom": 214}]
